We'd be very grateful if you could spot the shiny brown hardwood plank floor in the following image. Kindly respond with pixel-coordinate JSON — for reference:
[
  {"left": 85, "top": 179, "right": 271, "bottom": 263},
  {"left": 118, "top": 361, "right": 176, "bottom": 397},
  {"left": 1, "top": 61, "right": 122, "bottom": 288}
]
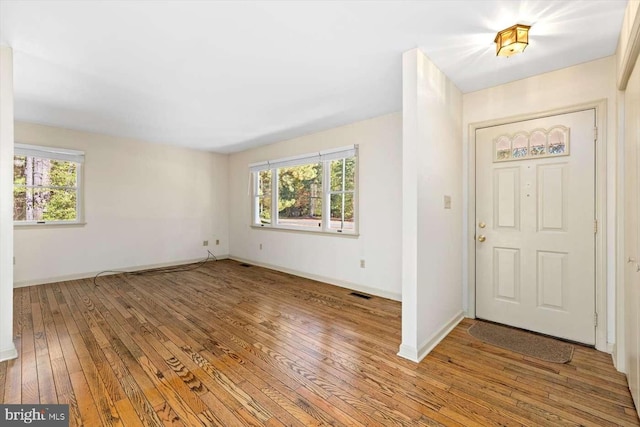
[{"left": 0, "top": 260, "right": 640, "bottom": 427}]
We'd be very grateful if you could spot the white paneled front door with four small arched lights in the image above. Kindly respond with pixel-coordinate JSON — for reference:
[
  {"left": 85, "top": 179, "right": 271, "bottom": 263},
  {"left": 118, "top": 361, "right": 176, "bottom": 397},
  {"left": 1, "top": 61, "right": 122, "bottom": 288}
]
[{"left": 474, "top": 109, "right": 595, "bottom": 344}]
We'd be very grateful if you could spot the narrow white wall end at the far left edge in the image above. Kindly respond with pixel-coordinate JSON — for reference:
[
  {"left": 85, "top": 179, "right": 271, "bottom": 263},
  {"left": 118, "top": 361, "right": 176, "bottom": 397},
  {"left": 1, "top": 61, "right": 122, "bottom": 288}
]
[{"left": 0, "top": 46, "right": 18, "bottom": 361}]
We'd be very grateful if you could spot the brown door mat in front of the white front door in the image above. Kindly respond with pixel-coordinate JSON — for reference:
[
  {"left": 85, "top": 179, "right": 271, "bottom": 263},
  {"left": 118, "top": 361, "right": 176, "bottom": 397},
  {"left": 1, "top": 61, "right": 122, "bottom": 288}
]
[{"left": 468, "top": 322, "right": 573, "bottom": 363}]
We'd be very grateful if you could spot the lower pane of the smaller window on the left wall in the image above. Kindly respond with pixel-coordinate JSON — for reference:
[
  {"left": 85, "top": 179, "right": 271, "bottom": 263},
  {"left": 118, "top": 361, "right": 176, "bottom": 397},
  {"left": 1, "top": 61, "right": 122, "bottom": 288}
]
[{"left": 13, "top": 187, "right": 78, "bottom": 221}]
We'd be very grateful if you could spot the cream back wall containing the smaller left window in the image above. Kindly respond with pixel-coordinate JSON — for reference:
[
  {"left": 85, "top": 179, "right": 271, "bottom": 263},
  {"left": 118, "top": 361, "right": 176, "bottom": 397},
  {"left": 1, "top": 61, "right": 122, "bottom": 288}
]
[{"left": 14, "top": 122, "right": 229, "bottom": 286}]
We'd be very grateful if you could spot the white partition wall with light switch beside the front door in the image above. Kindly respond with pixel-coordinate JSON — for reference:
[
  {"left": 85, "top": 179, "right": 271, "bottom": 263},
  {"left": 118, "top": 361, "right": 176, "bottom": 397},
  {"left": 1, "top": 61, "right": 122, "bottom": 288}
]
[{"left": 399, "top": 49, "right": 463, "bottom": 361}]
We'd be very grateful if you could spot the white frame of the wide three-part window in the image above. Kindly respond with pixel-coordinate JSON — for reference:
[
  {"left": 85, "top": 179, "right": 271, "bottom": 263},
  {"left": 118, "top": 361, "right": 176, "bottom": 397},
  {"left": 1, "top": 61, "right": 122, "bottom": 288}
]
[{"left": 249, "top": 145, "right": 360, "bottom": 237}]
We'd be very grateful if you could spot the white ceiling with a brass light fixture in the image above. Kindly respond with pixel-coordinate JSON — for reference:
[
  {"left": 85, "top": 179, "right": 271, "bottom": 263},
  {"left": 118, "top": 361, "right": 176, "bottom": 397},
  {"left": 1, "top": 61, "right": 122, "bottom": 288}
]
[{"left": 0, "top": 0, "right": 627, "bottom": 153}]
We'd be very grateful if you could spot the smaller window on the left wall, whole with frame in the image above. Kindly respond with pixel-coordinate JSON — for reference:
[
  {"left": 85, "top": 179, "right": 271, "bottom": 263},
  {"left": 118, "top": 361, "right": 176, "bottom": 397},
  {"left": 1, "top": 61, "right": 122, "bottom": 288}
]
[{"left": 13, "top": 144, "right": 84, "bottom": 224}]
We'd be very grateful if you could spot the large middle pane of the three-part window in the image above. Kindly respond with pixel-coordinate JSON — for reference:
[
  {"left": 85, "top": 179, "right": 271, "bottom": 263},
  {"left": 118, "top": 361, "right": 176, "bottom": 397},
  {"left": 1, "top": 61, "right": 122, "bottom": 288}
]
[{"left": 278, "top": 163, "right": 322, "bottom": 228}]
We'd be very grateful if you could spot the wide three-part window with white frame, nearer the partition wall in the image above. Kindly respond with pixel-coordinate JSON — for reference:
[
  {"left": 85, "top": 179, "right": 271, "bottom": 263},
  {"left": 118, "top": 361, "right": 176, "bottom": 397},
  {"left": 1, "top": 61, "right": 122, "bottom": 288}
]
[{"left": 249, "top": 146, "right": 357, "bottom": 234}]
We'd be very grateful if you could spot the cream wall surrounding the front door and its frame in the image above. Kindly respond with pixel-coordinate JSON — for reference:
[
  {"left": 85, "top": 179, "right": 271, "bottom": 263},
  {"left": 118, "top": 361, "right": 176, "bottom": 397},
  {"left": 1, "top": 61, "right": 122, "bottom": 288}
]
[{"left": 463, "top": 56, "right": 617, "bottom": 343}]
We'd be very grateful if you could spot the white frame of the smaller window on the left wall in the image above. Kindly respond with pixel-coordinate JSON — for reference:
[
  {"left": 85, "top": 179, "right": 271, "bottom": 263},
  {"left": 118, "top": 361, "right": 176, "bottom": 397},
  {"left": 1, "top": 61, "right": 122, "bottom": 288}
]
[{"left": 12, "top": 143, "right": 85, "bottom": 227}]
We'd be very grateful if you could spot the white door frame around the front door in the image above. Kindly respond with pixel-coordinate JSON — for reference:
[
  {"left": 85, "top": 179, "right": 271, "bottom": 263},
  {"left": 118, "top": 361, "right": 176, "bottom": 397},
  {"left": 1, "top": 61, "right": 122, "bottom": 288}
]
[{"left": 464, "top": 99, "right": 614, "bottom": 353}]
